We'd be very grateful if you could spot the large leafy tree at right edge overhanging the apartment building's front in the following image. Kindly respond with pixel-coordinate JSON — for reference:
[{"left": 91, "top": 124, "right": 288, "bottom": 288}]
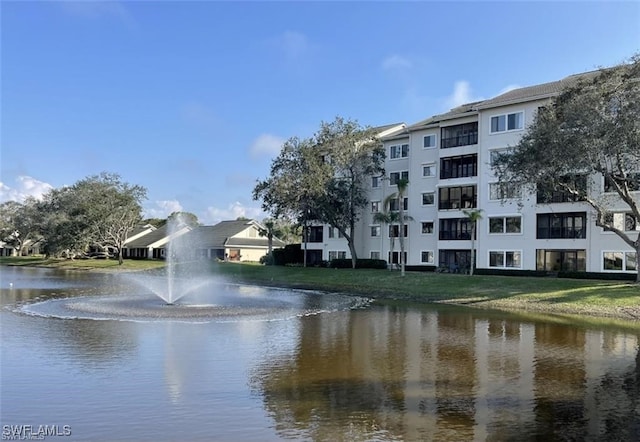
[{"left": 495, "top": 55, "right": 640, "bottom": 282}]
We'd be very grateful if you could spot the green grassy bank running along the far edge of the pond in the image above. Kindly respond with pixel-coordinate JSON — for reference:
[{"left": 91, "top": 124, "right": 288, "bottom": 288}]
[{"left": 0, "top": 257, "right": 640, "bottom": 327}]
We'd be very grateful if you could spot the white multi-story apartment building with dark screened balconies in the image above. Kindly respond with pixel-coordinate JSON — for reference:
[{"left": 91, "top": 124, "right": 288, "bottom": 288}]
[{"left": 307, "top": 73, "right": 640, "bottom": 272}]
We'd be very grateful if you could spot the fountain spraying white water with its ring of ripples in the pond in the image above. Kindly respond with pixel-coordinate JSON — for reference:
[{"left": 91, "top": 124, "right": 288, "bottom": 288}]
[{"left": 21, "top": 220, "right": 368, "bottom": 322}]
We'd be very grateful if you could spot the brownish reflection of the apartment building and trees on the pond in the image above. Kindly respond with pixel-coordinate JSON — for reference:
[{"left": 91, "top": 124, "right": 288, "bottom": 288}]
[{"left": 252, "top": 307, "right": 640, "bottom": 441}]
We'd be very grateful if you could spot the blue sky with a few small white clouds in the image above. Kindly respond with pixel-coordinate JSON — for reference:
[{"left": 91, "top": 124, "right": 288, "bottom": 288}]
[{"left": 0, "top": 1, "right": 640, "bottom": 224}]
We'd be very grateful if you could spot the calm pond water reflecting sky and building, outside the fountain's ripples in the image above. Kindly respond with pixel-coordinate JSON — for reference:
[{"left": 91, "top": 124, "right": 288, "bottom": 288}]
[{"left": 0, "top": 267, "right": 640, "bottom": 441}]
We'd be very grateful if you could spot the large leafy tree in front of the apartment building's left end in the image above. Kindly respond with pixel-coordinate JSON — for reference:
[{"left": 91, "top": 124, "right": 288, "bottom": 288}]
[{"left": 253, "top": 117, "right": 384, "bottom": 267}]
